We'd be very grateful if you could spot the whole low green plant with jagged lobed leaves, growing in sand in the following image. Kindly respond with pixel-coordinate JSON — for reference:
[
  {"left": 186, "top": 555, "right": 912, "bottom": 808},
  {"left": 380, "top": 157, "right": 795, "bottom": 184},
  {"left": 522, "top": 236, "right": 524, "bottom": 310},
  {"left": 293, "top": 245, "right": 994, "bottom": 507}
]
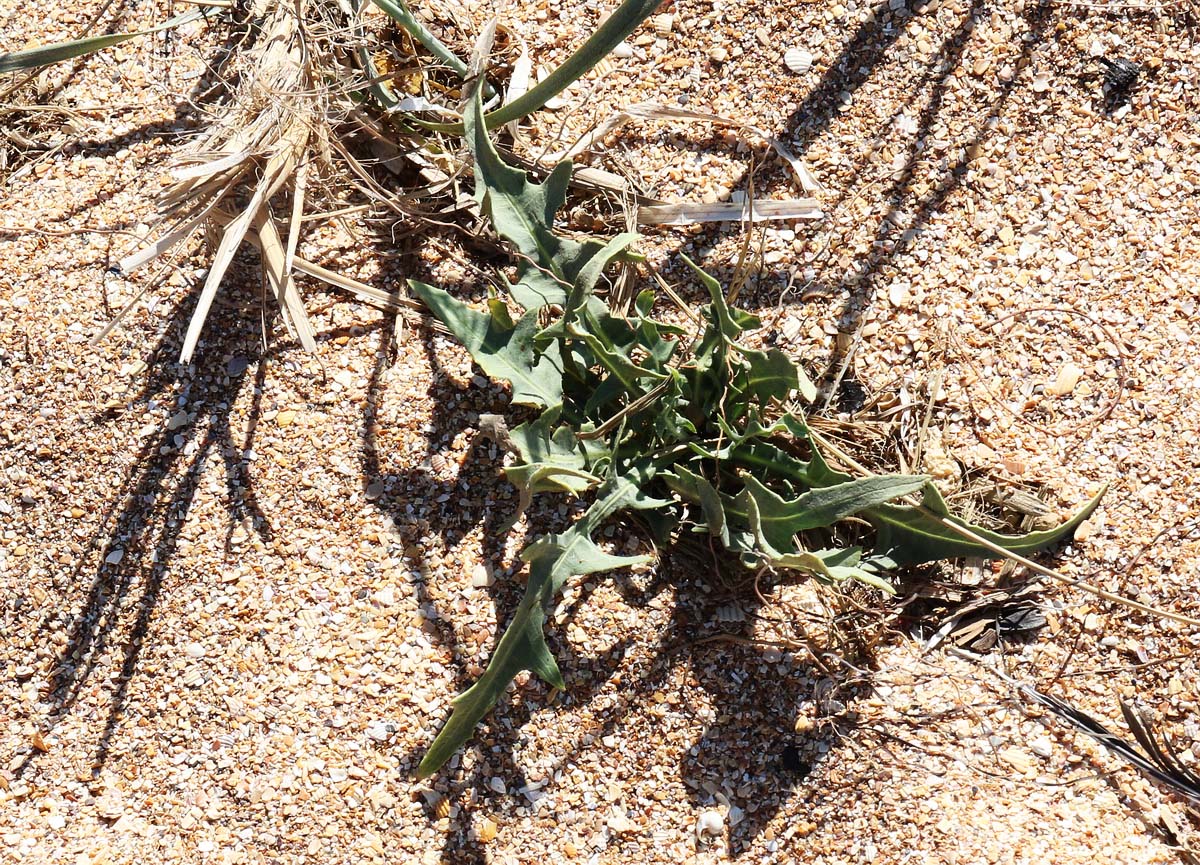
[{"left": 410, "top": 89, "right": 1097, "bottom": 776}]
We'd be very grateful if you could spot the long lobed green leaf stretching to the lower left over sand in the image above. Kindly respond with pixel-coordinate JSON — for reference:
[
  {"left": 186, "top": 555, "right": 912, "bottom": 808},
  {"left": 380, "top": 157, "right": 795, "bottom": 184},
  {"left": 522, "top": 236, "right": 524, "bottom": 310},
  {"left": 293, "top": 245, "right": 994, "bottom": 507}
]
[{"left": 416, "top": 467, "right": 667, "bottom": 777}]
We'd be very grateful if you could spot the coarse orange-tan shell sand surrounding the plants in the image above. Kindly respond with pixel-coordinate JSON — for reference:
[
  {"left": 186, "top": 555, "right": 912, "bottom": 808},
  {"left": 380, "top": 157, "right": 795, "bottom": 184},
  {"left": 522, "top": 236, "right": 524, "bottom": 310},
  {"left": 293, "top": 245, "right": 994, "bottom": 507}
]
[{"left": 0, "top": 0, "right": 1200, "bottom": 864}]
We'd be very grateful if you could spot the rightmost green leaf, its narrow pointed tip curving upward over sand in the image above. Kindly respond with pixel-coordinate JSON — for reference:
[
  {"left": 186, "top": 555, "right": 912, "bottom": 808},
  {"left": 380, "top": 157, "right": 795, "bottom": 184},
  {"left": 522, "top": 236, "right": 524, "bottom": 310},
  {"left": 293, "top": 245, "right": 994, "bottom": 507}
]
[{"left": 863, "top": 483, "right": 1108, "bottom": 566}]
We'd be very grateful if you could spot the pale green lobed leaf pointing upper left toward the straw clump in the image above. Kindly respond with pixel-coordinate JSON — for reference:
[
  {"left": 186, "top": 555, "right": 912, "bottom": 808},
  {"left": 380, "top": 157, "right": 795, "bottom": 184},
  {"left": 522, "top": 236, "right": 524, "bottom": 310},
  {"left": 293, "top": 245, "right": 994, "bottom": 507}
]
[{"left": 408, "top": 280, "right": 563, "bottom": 408}]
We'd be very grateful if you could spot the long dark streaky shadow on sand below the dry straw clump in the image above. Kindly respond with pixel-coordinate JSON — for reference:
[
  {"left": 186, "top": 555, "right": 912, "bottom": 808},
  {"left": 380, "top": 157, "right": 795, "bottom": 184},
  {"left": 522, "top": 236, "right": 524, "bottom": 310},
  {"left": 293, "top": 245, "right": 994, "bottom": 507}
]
[{"left": 13, "top": 260, "right": 274, "bottom": 777}]
